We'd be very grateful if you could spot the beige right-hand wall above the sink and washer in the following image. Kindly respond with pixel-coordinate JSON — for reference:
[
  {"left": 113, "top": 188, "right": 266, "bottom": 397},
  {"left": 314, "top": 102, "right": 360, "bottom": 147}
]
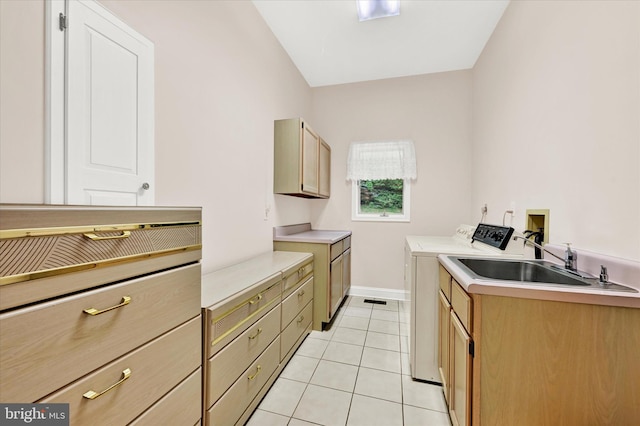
[{"left": 472, "top": 1, "right": 640, "bottom": 262}]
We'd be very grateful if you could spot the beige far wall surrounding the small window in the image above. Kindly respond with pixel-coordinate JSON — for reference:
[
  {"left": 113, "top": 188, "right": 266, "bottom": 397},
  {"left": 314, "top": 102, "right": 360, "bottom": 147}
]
[{"left": 313, "top": 71, "right": 472, "bottom": 290}]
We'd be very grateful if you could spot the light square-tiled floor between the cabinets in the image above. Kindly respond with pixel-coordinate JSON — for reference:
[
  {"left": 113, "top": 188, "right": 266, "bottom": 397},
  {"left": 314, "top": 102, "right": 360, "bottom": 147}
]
[{"left": 247, "top": 297, "right": 451, "bottom": 426}]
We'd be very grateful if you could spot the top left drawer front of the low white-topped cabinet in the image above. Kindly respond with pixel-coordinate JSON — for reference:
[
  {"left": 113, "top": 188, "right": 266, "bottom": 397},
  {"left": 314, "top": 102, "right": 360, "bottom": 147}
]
[{"left": 207, "top": 280, "right": 282, "bottom": 358}]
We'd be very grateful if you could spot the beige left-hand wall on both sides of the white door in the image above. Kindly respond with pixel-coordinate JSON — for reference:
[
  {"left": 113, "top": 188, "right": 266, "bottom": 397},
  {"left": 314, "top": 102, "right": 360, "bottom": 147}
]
[{"left": 0, "top": 0, "right": 311, "bottom": 271}]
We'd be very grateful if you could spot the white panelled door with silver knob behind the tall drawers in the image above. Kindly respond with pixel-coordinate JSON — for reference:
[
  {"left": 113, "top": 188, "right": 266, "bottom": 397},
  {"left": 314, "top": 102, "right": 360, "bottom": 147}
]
[{"left": 64, "top": 0, "right": 155, "bottom": 206}]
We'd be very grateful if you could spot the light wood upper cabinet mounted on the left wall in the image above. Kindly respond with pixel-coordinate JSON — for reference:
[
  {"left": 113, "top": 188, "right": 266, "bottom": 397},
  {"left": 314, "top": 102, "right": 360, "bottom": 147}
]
[{"left": 273, "top": 118, "right": 331, "bottom": 198}]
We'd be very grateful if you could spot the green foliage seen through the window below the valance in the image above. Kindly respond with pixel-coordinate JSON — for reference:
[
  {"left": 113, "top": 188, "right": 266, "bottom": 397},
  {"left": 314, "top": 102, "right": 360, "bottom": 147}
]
[{"left": 358, "top": 179, "right": 404, "bottom": 214}]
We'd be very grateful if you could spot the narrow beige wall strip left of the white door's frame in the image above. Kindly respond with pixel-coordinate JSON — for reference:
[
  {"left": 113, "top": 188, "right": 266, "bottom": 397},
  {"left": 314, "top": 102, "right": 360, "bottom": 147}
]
[{"left": 0, "top": 1, "right": 45, "bottom": 203}]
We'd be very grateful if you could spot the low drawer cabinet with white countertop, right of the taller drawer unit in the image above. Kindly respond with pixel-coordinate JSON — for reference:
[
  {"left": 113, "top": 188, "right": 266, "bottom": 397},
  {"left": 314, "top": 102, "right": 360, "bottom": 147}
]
[{"left": 201, "top": 252, "right": 314, "bottom": 425}]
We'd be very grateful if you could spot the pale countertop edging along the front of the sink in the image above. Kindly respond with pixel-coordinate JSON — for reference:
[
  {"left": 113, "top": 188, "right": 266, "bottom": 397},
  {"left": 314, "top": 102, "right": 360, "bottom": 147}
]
[{"left": 438, "top": 255, "right": 640, "bottom": 308}]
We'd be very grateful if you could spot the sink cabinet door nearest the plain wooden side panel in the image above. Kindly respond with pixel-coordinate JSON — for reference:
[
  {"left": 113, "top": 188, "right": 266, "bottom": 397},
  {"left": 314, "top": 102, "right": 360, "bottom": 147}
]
[{"left": 449, "top": 310, "right": 472, "bottom": 426}]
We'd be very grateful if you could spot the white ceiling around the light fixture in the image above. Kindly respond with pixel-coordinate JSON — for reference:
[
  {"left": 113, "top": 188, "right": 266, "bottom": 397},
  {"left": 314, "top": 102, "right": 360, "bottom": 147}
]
[{"left": 253, "top": 0, "right": 509, "bottom": 87}]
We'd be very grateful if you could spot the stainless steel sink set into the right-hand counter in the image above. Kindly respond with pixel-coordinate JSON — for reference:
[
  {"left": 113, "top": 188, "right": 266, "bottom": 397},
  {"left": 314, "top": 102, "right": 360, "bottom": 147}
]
[{"left": 450, "top": 256, "right": 637, "bottom": 293}]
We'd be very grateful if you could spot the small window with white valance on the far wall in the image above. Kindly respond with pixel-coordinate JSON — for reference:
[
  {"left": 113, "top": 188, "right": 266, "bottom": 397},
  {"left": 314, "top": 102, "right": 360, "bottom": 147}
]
[{"left": 347, "top": 141, "right": 416, "bottom": 222}]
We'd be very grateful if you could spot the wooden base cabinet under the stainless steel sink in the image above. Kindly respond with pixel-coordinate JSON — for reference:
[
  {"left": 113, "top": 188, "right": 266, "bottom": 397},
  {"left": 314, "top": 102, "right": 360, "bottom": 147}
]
[{"left": 440, "top": 262, "right": 640, "bottom": 426}]
